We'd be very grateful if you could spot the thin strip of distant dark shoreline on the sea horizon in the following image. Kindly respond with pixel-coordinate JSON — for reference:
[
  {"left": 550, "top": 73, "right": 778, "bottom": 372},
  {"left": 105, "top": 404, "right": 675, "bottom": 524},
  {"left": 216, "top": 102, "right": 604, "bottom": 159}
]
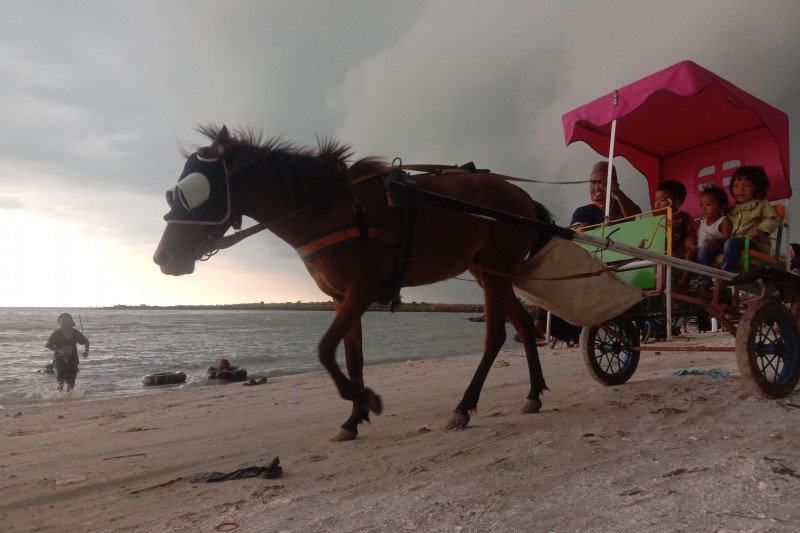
[{"left": 102, "top": 301, "right": 535, "bottom": 313}]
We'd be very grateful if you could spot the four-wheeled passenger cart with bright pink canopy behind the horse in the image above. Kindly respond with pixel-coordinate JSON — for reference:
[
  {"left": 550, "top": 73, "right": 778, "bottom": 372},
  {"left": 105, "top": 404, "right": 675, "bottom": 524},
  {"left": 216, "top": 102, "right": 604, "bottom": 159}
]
[{"left": 563, "top": 61, "right": 800, "bottom": 397}]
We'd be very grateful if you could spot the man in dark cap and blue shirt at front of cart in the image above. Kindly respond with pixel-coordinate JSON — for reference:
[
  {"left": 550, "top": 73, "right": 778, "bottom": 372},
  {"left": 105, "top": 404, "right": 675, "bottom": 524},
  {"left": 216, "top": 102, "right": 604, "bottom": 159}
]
[{"left": 569, "top": 161, "right": 642, "bottom": 228}]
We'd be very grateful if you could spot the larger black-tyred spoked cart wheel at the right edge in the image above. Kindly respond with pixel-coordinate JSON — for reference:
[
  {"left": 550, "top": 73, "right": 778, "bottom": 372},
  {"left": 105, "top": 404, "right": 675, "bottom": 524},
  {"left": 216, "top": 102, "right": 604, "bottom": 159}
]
[{"left": 736, "top": 300, "right": 800, "bottom": 398}]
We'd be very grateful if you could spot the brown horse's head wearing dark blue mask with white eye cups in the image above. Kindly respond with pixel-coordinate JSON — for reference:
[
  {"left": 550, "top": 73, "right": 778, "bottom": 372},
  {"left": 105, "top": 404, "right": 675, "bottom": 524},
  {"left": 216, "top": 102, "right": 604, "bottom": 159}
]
[{"left": 153, "top": 126, "right": 237, "bottom": 276}]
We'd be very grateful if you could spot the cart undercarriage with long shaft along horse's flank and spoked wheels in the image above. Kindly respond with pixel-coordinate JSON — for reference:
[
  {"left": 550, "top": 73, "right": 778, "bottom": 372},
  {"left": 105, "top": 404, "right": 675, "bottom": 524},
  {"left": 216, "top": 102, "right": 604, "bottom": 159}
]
[{"left": 386, "top": 168, "right": 800, "bottom": 398}]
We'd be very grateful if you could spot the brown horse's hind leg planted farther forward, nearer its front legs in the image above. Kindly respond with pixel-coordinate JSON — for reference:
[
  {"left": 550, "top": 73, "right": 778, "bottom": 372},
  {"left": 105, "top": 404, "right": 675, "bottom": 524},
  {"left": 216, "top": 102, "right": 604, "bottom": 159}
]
[{"left": 445, "top": 275, "right": 506, "bottom": 430}]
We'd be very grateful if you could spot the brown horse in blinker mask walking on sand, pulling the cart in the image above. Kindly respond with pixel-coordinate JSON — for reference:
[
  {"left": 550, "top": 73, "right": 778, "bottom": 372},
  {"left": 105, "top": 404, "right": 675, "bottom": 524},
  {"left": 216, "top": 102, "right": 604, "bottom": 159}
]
[{"left": 153, "top": 126, "right": 550, "bottom": 440}]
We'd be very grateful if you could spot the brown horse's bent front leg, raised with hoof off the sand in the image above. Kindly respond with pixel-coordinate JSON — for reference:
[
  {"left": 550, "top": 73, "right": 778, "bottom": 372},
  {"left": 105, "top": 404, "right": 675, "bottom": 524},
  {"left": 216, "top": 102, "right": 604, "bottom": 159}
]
[{"left": 319, "top": 292, "right": 383, "bottom": 440}]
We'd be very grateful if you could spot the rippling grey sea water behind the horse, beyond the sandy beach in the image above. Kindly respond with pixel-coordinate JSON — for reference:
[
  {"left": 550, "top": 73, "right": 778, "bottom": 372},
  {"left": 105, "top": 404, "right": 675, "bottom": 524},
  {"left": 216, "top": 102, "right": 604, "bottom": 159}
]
[{"left": 0, "top": 308, "right": 506, "bottom": 406}]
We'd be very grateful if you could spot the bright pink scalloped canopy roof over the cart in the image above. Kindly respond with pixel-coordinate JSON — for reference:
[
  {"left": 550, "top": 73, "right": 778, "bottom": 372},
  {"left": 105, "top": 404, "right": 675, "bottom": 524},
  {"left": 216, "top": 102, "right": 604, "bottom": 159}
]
[{"left": 562, "top": 61, "right": 792, "bottom": 214}]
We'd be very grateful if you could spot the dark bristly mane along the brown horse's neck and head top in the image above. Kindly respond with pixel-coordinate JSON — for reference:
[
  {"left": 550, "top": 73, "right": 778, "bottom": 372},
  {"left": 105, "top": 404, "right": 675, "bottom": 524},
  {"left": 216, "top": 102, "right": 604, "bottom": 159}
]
[{"left": 189, "top": 124, "right": 388, "bottom": 206}]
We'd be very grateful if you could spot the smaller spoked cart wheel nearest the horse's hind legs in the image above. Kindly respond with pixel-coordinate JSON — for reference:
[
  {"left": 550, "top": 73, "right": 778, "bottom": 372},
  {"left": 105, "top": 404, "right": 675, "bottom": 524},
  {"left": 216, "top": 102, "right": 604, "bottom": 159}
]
[{"left": 581, "top": 320, "right": 639, "bottom": 385}]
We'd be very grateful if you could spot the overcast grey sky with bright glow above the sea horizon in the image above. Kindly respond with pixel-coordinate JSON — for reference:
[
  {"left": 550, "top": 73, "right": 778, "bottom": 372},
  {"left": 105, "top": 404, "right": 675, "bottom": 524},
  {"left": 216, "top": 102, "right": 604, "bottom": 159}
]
[{"left": 0, "top": 0, "right": 800, "bottom": 306}]
